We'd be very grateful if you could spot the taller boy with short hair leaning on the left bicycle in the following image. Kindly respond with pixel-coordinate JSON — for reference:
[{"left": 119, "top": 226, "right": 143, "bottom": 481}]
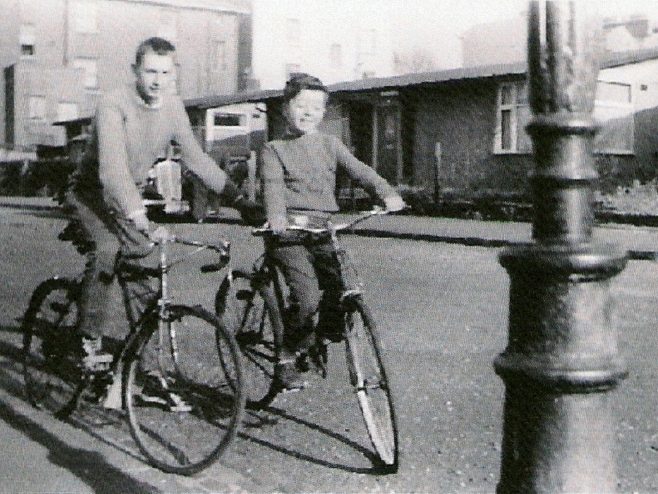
[{"left": 65, "top": 37, "right": 260, "bottom": 373}]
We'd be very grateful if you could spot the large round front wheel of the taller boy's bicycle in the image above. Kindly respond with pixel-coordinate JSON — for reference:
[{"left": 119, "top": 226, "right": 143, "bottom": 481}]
[{"left": 124, "top": 305, "right": 245, "bottom": 475}]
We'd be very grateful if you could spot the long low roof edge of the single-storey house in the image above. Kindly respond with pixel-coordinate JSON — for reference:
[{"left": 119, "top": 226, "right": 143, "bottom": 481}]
[{"left": 185, "top": 47, "right": 658, "bottom": 109}]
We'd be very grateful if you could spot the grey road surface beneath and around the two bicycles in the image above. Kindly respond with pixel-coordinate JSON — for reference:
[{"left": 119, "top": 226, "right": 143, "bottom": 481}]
[{"left": 0, "top": 209, "right": 658, "bottom": 493}]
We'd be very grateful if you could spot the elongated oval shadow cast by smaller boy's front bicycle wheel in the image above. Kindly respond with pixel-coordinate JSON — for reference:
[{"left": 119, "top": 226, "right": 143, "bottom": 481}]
[{"left": 238, "top": 406, "right": 384, "bottom": 475}]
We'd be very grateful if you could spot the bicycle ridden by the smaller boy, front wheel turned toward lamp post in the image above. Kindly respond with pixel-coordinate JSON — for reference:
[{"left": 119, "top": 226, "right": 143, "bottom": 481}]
[{"left": 215, "top": 209, "right": 398, "bottom": 472}]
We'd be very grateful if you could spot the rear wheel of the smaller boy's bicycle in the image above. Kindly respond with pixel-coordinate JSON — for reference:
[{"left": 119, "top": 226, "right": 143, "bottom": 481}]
[{"left": 215, "top": 271, "right": 279, "bottom": 410}]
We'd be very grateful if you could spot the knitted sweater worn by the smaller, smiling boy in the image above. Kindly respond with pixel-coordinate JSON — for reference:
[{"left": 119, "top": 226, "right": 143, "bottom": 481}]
[{"left": 260, "top": 133, "right": 397, "bottom": 220}]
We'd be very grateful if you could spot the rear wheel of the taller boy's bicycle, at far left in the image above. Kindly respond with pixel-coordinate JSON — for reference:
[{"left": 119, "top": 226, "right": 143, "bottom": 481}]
[{"left": 21, "top": 278, "right": 84, "bottom": 418}]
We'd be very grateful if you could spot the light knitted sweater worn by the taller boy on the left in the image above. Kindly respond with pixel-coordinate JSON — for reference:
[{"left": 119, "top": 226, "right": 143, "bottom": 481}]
[{"left": 74, "top": 86, "right": 226, "bottom": 215}]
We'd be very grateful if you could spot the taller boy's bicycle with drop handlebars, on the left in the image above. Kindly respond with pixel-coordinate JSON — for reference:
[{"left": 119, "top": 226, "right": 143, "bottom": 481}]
[{"left": 22, "top": 212, "right": 245, "bottom": 475}]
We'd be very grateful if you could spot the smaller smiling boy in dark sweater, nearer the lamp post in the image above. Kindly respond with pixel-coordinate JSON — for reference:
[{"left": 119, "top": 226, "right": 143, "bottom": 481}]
[{"left": 260, "top": 74, "right": 405, "bottom": 390}]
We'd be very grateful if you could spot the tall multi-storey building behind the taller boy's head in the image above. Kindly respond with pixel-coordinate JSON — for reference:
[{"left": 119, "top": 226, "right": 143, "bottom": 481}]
[{"left": 0, "top": 0, "right": 251, "bottom": 150}]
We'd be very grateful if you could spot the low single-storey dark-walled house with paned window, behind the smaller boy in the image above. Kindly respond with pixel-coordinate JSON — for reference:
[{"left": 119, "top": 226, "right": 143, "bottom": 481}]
[{"left": 188, "top": 49, "right": 658, "bottom": 201}]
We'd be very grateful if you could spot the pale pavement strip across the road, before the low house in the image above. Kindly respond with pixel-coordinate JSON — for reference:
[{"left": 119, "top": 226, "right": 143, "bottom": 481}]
[{"left": 5, "top": 196, "right": 658, "bottom": 261}]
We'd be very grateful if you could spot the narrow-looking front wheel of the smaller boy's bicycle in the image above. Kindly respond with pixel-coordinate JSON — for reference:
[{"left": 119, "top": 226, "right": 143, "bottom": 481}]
[{"left": 345, "top": 298, "right": 399, "bottom": 473}]
